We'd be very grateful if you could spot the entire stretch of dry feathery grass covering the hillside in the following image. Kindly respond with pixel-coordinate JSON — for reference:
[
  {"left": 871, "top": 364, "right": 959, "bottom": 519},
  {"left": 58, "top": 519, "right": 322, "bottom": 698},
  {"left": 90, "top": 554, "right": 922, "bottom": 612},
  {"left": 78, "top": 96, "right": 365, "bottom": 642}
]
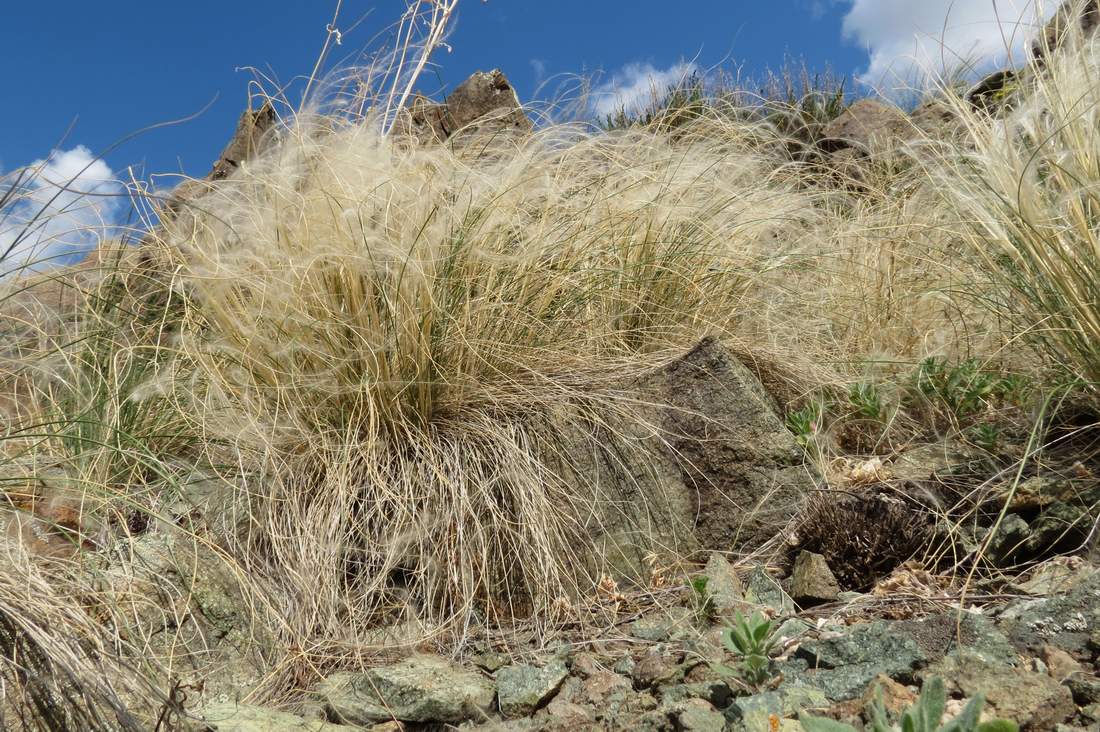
[{"left": 0, "top": 12, "right": 1100, "bottom": 729}]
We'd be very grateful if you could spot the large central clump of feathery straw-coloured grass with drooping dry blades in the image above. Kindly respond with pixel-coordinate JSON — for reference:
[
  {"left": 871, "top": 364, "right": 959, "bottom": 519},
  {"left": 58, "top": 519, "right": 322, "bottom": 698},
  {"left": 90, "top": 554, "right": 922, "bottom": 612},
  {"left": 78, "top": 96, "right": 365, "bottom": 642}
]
[{"left": 160, "top": 105, "right": 805, "bottom": 638}]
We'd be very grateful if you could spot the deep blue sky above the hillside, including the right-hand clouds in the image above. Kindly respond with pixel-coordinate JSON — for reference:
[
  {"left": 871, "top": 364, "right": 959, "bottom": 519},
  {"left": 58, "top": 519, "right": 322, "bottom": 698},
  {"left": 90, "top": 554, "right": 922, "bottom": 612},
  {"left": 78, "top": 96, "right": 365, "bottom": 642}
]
[{"left": 0, "top": 0, "right": 1055, "bottom": 264}]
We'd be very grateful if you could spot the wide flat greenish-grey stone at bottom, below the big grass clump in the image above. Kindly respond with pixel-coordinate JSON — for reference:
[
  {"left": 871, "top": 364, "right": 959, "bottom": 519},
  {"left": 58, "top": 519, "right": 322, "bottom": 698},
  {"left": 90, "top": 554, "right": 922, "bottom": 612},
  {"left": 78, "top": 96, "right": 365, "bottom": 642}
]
[{"left": 318, "top": 655, "right": 495, "bottom": 724}]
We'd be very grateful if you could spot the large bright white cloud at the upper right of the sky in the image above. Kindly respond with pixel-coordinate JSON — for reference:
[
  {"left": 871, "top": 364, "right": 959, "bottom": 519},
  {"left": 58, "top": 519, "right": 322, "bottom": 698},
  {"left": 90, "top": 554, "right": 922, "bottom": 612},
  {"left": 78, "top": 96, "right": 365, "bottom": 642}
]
[{"left": 844, "top": 0, "right": 1057, "bottom": 89}]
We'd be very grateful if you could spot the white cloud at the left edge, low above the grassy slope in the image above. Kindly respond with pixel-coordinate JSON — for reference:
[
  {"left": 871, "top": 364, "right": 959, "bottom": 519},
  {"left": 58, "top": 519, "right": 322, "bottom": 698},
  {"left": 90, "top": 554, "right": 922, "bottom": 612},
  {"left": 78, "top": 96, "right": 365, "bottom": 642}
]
[{"left": 0, "top": 145, "right": 123, "bottom": 276}]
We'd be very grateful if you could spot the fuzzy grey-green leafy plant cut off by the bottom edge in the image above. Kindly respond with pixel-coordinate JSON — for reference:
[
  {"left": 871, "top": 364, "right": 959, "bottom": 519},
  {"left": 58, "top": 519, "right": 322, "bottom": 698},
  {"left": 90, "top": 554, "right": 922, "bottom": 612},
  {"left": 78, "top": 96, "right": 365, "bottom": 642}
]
[{"left": 799, "top": 677, "right": 1019, "bottom": 732}]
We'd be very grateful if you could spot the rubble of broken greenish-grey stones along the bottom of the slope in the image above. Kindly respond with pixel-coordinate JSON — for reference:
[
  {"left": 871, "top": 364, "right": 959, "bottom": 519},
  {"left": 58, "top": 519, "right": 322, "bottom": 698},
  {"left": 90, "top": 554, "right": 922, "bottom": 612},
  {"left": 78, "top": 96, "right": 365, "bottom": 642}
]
[{"left": 189, "top": 554, "right": 1100, "bottom": 732}]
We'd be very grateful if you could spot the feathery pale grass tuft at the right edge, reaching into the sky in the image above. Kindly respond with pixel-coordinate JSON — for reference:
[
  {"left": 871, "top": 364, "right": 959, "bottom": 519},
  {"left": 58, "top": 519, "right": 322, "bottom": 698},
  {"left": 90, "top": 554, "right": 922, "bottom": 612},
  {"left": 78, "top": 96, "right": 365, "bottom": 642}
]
[{"left": 933, "top": 24, "right": 1100, "bottom": 384}]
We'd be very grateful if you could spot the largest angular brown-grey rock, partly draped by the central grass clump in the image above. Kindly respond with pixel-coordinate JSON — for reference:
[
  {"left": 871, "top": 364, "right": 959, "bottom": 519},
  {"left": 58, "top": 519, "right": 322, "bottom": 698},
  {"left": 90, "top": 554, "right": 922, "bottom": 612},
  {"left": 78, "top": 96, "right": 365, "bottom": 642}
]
[{"left": 576, "top": 338, "right": 815, "bottom": 582}]
